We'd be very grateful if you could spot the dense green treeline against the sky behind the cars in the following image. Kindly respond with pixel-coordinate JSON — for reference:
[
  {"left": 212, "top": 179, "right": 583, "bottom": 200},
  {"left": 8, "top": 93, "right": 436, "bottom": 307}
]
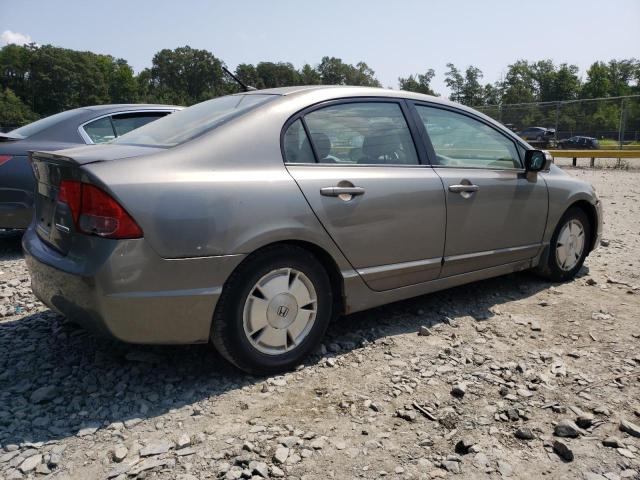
[{"left": 0, "top": 44, "right": 640, "bottom": 126}]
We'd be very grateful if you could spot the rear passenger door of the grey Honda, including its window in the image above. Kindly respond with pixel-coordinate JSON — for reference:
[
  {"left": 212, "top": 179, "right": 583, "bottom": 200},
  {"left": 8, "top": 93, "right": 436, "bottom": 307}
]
[{"left": 283, "top": 99, "right": 445, "bottom": 290}]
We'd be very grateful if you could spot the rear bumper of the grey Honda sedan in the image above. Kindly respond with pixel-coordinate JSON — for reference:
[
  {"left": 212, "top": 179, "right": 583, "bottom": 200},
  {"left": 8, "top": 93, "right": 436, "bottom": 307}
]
[{"left": 22, "top": 228, "right": 244, "bottom": 344}]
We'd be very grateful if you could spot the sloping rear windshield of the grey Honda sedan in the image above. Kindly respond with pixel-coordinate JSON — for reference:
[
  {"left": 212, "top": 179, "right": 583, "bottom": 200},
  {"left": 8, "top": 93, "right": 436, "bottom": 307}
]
[{"left": 111, "top": 94, "right": 276, "bottom": 147}]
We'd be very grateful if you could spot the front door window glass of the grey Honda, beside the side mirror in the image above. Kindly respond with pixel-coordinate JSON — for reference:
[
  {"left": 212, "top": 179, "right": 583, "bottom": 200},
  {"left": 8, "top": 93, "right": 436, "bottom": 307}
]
[{"left": 416, "top": 106, "right": 521, "bottom": 168}]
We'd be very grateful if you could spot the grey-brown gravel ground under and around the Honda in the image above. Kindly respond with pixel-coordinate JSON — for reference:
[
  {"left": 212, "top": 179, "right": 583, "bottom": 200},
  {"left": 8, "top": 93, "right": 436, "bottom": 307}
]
[{"left": 0, "top": 170, "right": 640, "bottom": 480}]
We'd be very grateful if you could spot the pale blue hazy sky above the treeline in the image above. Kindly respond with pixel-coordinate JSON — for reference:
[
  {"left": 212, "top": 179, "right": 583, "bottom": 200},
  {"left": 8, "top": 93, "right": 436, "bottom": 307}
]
[{"left": 0, "top": 0, "right": 640, "bottom": 94}]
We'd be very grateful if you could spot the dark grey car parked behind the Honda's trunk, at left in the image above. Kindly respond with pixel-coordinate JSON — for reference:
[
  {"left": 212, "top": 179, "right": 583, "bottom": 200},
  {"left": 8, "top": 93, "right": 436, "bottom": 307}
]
[{"left": 0, "top": 104, "right": 182, "bottom": 228}]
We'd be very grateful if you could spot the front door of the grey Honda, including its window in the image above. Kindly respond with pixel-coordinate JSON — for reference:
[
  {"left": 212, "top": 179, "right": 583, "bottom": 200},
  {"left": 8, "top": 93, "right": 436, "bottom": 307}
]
[{"left": 414, "top": 104, "right": 548, "bottom": 277}]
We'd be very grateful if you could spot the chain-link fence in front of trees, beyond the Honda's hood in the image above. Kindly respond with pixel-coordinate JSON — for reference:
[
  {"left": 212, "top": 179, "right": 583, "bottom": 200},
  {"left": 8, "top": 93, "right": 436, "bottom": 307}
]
[{"left": 474, "top": 95, "right": 640, "bottom": 148}]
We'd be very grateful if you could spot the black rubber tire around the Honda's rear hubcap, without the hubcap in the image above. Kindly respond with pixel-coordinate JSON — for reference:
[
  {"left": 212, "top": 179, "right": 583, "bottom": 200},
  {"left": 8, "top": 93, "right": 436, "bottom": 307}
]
[{"left": 211, "top": 245, "right": 333, "bottom": 375}]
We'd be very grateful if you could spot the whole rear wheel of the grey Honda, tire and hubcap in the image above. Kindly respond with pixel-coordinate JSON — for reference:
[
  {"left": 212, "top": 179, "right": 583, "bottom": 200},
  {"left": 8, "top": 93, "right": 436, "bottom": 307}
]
[{"left": 211, "top": 245, "right": 333, "bottom": 374}]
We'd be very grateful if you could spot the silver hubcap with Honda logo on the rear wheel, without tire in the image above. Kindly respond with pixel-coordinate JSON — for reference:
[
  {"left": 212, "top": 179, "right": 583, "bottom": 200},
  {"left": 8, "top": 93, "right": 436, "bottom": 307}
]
[{"left": 242, "top": 268, "right": 318, "bottom": 355}]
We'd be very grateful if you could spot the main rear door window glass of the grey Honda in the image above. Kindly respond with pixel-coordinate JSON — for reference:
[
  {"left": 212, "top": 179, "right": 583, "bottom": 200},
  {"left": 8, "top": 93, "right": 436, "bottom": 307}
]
[{"left": 305, "top": 102, "right": 418, "bottom": 165}]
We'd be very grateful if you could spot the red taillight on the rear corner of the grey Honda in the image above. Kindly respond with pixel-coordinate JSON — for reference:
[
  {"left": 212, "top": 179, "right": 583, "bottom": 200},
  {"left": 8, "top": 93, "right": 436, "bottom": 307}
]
[{"left": 58, "top": 180, "right": 142, "bottom": 239}]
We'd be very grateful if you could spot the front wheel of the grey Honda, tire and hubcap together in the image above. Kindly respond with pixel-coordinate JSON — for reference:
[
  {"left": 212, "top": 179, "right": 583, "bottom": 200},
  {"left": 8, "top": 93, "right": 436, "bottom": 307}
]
[{"left": 537, "top": 207, "right": 591, "bottom": 282}]
